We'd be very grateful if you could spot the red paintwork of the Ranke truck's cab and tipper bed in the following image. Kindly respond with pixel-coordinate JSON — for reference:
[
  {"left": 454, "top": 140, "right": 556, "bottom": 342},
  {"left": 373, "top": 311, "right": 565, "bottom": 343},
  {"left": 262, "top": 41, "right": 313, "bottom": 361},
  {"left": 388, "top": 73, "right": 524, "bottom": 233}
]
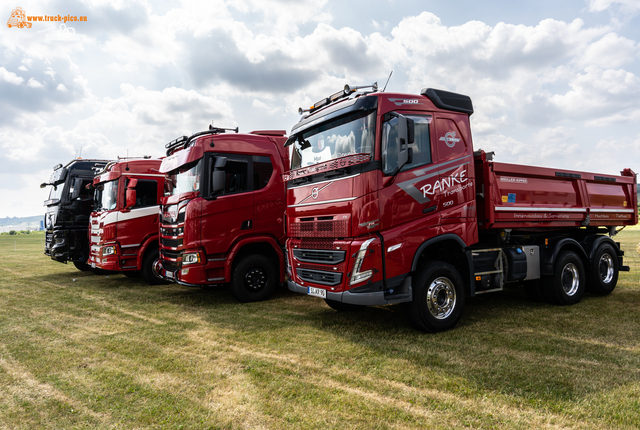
[{"left": 284, "top": 93, "right": 638, "bottom": 293}]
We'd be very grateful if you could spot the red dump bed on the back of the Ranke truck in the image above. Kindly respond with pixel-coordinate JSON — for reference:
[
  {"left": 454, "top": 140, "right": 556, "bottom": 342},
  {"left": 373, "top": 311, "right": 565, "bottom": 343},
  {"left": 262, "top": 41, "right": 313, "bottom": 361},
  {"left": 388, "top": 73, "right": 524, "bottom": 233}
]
[{"left": 475, "top": 151, "right": 638, "bottom": 230}]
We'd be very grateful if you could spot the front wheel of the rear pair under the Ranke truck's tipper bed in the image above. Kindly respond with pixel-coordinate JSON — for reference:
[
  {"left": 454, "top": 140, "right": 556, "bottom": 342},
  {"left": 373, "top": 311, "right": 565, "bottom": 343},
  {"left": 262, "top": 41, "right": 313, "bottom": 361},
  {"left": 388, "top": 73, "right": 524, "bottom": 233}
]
[{"left": 544, "top": 251, "right": 586, "bottom": 306}]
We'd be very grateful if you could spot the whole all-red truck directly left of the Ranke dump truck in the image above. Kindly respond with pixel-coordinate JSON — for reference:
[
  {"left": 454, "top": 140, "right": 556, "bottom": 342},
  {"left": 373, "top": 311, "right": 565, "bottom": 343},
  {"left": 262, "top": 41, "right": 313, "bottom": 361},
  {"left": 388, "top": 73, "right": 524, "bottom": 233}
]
[{"left": 158, "top": 127, "right": 289, "bottom": 302}]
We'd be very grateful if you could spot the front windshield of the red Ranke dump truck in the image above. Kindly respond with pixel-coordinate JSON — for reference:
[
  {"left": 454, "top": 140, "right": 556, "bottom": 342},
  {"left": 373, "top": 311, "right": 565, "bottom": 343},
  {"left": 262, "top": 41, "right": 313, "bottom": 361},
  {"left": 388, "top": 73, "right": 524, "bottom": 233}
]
[{"left": 291, "top": 111, "right": 376, "bottom": 170}]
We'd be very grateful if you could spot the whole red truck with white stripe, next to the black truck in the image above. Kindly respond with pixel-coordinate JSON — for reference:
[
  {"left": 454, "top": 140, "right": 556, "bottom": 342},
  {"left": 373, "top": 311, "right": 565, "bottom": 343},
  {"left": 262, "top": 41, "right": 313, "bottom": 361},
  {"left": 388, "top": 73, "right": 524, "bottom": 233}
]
[{"left": 89, "top": 157, "right": 165, "bottom": 284}]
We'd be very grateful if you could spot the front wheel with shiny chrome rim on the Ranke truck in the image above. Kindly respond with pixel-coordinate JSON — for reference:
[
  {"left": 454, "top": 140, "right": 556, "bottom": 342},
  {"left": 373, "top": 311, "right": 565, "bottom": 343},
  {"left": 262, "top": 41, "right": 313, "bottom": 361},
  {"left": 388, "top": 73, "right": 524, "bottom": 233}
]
[{"left": 404, "top": 261, "right": 465, "bottom": 333}]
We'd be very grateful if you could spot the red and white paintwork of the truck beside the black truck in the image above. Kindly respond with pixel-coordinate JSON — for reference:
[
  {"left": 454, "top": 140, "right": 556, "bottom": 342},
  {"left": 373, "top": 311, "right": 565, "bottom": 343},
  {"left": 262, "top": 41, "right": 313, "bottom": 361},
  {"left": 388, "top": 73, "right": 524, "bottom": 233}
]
[{"left": 88, "top": 159, "right": 165, "bottom": 271}]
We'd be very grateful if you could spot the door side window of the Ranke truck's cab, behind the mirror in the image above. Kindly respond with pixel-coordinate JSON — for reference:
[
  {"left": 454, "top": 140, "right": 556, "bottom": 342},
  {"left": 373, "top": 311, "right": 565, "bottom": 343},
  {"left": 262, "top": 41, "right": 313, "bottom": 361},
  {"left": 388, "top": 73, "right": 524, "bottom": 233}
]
[{"left": 382, "top": 115, "right": 431, "bottom": 174}]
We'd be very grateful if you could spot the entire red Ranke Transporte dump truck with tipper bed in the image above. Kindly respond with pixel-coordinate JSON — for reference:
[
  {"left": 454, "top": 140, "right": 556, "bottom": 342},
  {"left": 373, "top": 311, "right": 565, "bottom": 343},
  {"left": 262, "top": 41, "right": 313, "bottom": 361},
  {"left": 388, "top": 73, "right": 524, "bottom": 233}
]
[{"left": 283, "top": 84, "right": 638, "bottom": 332}]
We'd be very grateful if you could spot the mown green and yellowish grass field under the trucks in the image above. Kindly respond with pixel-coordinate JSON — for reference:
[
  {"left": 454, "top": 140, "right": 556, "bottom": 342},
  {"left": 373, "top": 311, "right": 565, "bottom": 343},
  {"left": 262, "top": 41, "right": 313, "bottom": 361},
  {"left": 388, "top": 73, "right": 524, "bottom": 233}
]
[{"left": 0, "top": 228, "right": 640, "bottom": 429}]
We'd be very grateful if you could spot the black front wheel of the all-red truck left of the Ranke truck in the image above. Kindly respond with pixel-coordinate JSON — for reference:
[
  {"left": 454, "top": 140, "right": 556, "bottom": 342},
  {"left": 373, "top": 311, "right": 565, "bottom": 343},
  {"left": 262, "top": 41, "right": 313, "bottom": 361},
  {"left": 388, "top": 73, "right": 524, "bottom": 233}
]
[{"left": 229, "top": 254, "right": 278, "bottom": 303}]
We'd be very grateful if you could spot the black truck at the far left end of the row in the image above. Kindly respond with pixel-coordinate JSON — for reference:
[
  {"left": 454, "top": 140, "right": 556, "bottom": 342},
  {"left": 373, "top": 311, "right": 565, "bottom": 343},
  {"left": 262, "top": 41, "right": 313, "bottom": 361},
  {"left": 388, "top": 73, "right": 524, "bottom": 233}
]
[{"left": 40, "top": 159, "right": 107, "bottom": 270}]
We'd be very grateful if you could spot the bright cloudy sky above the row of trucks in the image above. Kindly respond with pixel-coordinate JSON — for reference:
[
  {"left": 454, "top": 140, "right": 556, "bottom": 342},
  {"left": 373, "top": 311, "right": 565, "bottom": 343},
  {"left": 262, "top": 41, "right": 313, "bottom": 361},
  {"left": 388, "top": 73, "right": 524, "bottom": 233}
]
[{"left": 0, "top": 0, "right": 640, "bottom": 217}]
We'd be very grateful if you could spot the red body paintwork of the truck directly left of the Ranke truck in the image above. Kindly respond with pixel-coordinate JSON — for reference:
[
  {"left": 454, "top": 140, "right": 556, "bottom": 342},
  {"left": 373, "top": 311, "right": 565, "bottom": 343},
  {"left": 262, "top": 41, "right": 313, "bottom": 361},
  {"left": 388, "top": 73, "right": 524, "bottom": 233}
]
[{"left": 158, "top": 130, "right": 289, "bottom": 285}]
